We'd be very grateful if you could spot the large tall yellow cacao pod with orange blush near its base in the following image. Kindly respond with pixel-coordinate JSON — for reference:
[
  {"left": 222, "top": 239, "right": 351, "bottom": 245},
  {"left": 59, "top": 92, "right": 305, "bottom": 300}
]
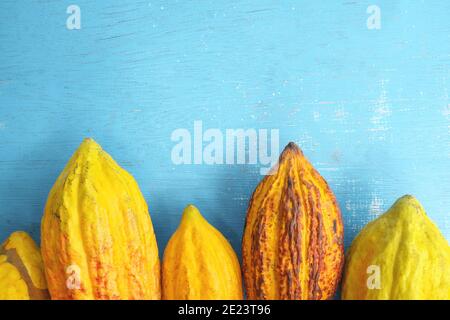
[{"left": 41, "top": 139, "right": 161, "bottom": 299}]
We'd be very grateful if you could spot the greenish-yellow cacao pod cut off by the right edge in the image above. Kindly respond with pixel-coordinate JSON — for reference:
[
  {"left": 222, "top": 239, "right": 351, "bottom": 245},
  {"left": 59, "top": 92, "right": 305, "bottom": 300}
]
[{"left": 342, "top": 195, "right": 450, "bottom": 300}]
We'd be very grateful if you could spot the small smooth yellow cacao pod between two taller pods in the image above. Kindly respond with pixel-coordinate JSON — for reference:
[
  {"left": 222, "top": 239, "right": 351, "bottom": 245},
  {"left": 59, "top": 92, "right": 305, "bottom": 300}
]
[{"left": 162, "top": 205, "right": 242, "bottom": 300}]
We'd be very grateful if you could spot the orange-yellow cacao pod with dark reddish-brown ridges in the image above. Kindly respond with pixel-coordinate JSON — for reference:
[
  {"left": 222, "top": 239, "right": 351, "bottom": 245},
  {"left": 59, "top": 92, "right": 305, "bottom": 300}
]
[{"left": 242, "top": 142, "right": 344, "bottom": 300}]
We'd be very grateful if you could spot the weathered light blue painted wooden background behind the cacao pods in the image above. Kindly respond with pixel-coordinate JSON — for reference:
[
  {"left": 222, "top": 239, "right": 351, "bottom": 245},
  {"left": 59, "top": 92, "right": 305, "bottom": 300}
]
[{"left": 0, "top": 0, "right": 450, "bottom": 262}]
